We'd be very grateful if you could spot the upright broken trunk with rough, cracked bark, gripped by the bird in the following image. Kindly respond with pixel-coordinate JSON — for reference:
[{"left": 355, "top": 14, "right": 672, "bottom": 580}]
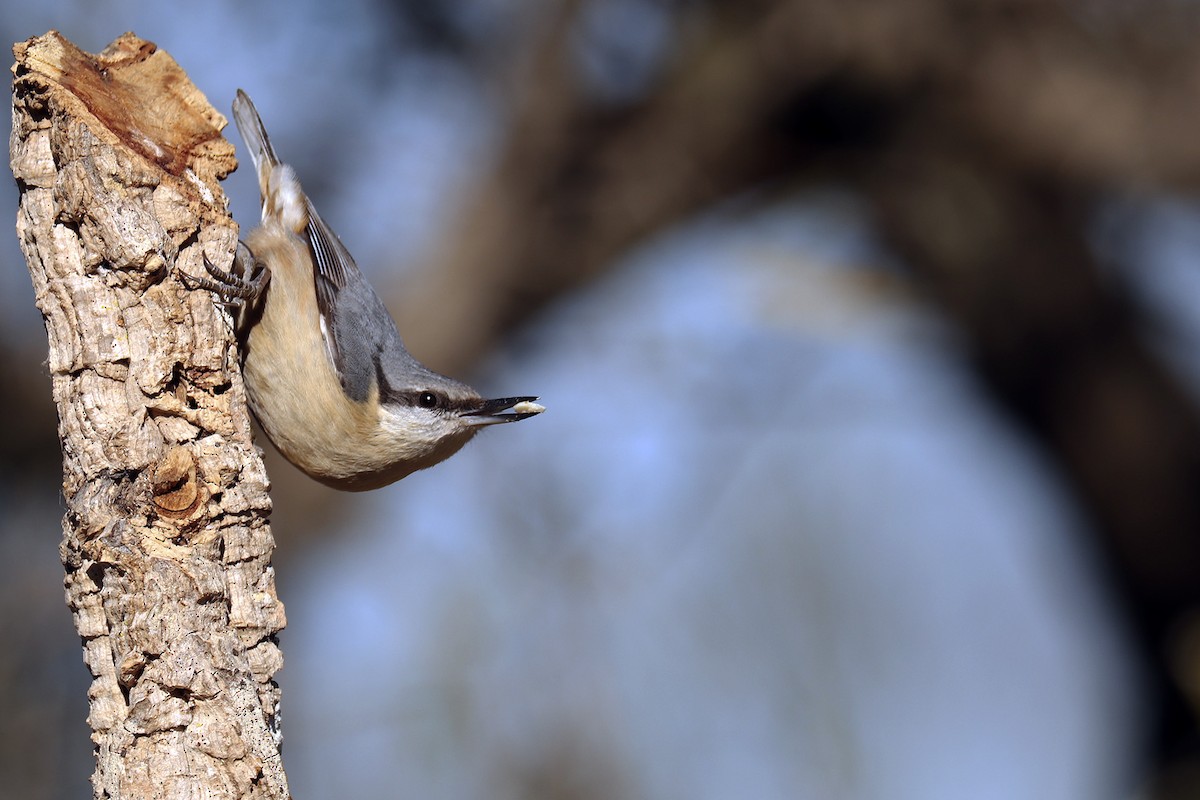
[{"left": 11, "top": 31, "right": 288, "bottom": 799}]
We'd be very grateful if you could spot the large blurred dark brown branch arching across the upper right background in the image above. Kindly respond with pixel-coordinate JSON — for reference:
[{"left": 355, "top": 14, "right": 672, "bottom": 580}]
[{"left": 401, "top": 0, "right": 1200, "bottom": 772}]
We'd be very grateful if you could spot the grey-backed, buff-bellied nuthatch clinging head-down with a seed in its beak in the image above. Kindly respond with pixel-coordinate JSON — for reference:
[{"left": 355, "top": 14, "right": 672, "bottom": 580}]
[{"left": 202, "top": 89, "right": 545, "bottom": 492}]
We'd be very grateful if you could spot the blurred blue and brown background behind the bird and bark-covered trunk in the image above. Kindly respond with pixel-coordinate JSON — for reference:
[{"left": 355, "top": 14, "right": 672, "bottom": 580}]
[{"left": 7, "top": 0, "right": 1200, "bottom": 800}]
